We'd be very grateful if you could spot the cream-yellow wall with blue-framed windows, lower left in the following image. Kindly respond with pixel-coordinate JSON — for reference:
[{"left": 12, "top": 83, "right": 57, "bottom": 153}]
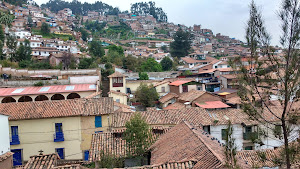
[{"left": 9, "top": 117, "right": 83, "bottom": 161}]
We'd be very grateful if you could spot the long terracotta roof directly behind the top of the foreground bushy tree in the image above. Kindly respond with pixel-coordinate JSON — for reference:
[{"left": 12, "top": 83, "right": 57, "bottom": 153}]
[{"left": 112, "top": 107, "right": 207, "bottom": 128}]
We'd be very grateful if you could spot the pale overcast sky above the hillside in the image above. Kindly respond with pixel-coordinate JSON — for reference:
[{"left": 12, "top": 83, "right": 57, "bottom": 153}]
[{"left": 35, "top": 0, "right": 281, "bottom": 45}]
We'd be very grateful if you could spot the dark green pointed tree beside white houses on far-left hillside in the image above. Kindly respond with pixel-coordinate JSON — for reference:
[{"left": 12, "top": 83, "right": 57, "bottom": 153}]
[{"left": 15, "top": 39, "right": 31, "bottom": 62}]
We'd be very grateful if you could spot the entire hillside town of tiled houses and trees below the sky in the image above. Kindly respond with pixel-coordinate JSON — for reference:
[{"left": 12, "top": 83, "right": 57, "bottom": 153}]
[{"left": 0, "top": 0, "right": 300, "bottom": 169}]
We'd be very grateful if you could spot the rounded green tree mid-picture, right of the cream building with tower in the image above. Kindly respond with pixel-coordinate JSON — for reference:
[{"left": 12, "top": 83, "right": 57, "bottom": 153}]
[{"left": 136, "top": 84, "right": 159, "bottom": 107}]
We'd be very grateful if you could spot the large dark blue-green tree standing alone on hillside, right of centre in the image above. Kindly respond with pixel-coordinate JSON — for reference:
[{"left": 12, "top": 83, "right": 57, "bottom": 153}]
[{"left": 170, "top": 28, "right": 192, "bottom": 57}]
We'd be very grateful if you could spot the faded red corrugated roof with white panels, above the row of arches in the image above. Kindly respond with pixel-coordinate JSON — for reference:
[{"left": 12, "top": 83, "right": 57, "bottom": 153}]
[{"left": 0, "top": 84, "right": 96, "bottom": 96}]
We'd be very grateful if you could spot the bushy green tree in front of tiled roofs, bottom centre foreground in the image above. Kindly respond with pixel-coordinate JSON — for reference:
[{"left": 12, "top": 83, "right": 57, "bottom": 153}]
[{"left": 124, "top": 113, "right": 152, "bottom": 157}]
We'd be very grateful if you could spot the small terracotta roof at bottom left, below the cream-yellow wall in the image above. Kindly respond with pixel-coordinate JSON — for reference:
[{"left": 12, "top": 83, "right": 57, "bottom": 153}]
[{"left": 24, "top": 153, "right": 60, "bottom": 169}]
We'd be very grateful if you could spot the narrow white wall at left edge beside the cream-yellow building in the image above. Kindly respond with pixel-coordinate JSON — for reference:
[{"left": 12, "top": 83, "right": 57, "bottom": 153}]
[{"left": 0, "top": 114, "right": 10, "bottom": 155}]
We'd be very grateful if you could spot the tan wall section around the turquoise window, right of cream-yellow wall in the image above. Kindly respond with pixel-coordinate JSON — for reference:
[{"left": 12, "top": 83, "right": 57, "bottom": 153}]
[{"left": 80, "top": 115, "right": 111, "bottom": 150}]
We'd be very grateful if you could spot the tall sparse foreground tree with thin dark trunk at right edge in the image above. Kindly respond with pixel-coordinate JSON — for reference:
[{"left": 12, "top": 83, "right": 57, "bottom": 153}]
[{"left": 231, "top": 0, "right": 300, "bottom": 168}]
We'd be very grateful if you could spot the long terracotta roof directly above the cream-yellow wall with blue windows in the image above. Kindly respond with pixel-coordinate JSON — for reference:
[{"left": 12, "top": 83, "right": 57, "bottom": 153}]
[{"left": 0, "top": 97, "right": 113, "bottom": 120}]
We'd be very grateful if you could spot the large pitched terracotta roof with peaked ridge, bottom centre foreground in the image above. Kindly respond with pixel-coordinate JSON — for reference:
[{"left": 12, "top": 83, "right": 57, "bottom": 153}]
[{"left": 150, "top": 121, "right": 225, "bottom": 168}]
